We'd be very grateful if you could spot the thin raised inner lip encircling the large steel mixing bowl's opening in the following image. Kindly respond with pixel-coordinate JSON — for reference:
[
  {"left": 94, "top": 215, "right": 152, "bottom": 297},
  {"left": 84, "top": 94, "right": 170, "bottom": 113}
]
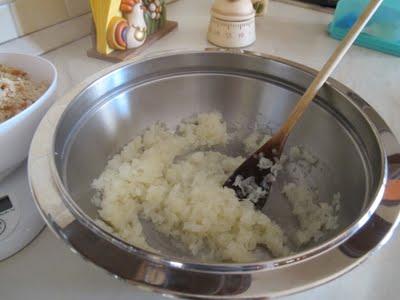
[{"left": 50, "top": 49, "right": 387, "bottom": 273}]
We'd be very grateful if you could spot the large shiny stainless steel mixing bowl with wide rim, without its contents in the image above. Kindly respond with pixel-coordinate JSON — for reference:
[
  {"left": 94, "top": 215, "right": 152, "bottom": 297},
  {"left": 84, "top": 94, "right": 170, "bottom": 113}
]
[{"left": 30, "top": 51, "right": 398, "bottom": 297}]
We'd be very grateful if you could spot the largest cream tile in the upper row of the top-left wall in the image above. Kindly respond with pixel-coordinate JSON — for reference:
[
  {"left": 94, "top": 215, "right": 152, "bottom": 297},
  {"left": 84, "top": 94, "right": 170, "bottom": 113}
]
[{"left": 10, "top": 0, "right": 69, "bottom": 35}]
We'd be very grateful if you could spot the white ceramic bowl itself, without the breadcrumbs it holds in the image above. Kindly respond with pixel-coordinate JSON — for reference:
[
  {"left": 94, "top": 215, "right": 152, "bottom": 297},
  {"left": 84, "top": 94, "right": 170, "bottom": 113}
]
[{"left": 0, "top": 53, "right": 57, "bottom": 181}]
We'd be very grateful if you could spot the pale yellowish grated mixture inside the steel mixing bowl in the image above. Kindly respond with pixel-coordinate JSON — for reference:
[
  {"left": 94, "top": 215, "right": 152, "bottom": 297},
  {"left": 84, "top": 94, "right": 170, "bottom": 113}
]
[{"left": 93, "top": 113, "right": 336, "bottom": 262}]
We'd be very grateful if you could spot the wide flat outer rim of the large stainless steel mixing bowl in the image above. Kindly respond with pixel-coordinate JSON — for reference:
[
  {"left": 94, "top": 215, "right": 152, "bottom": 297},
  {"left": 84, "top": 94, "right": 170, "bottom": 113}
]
[{"left": 28, "top": 49, "right": 400, "bottom": 299}]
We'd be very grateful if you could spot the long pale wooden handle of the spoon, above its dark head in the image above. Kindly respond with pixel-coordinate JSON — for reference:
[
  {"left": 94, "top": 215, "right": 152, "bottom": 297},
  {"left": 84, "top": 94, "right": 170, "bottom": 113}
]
[{"left": 277, "top": 0, "right": 383, "bottom": 146}]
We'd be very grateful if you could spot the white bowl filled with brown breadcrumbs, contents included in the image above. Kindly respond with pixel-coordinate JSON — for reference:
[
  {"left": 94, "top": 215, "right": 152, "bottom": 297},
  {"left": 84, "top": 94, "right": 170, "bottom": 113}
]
[{"left": 0, "top": 53, "right": 57, "bottom": 180}]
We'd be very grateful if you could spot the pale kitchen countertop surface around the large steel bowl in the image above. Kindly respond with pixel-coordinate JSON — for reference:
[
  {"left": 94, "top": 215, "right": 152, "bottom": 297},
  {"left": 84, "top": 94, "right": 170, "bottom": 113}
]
[{"left": 0, "top": 0, "right": 400, "bottom": 300}]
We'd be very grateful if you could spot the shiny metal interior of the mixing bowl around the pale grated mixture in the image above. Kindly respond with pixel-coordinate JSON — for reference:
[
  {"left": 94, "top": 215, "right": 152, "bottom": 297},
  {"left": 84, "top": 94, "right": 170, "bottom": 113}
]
[{"left": 52, "top": 51, "right": 386, "bottom": 272}]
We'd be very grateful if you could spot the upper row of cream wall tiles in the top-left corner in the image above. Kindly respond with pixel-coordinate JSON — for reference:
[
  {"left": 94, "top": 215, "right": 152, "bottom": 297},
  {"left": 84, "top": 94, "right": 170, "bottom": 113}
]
[{"left": 0, "top": 0, "right": 89, "bottom": 43}]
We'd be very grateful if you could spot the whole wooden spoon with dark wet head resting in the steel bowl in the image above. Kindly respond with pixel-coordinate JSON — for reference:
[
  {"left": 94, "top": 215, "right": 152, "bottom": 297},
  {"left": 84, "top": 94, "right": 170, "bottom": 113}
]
[{"left": 224, "top": 0, "right": 383, "bottom": 209}]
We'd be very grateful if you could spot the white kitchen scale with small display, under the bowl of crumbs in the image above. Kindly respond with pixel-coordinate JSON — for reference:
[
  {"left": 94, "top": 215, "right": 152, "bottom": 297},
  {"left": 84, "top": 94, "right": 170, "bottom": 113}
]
[{"left": 0, "top": 162, "right": 44, "bottom": 261}]
